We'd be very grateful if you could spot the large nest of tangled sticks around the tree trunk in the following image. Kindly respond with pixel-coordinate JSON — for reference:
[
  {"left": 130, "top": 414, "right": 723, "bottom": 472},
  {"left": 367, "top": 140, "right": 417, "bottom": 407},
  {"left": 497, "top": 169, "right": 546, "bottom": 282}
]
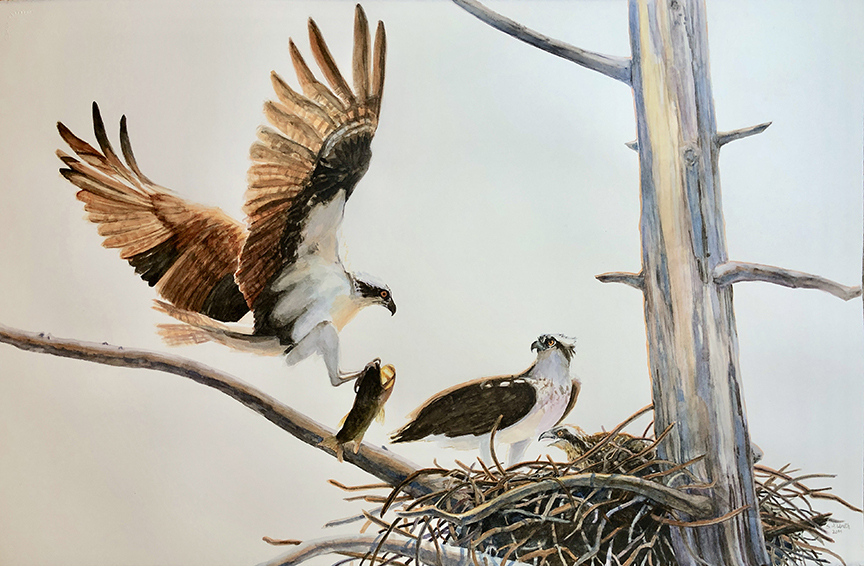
[{"left": 331, "top": 409, "right": 860, "bottom": 566}]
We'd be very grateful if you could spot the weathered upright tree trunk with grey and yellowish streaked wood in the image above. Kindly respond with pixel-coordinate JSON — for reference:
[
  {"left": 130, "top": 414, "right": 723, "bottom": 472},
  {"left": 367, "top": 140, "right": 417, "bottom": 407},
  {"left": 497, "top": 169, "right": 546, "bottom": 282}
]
[{"left": 630, "top": 0, "right": 769, "bottom": 566}]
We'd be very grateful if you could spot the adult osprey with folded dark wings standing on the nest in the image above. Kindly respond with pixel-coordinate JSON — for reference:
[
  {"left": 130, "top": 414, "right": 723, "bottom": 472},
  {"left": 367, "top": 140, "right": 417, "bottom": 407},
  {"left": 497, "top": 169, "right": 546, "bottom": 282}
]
[{"left": 391, "top": 334, "right": 581, "bottom": 465}]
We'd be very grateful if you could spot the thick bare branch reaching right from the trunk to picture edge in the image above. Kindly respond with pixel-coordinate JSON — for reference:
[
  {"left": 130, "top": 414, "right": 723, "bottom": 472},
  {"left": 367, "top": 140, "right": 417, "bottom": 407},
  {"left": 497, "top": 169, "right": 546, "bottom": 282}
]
[{"left": 714, "top": 261, "right": 861, "bottom": 301}]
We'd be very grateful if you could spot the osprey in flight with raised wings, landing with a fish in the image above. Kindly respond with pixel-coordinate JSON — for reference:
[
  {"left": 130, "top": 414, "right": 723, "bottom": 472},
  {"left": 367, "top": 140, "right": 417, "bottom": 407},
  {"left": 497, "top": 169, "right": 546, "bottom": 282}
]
[{"left": 57, "top": 5, "right": 396, "bottom": 385}]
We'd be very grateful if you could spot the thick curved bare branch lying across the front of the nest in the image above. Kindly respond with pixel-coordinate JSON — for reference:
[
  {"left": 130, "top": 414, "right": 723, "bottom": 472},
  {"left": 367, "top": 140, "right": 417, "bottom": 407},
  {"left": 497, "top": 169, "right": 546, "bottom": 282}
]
[{"left": 398, "top": 474, "right": 714, "bottom": 526}]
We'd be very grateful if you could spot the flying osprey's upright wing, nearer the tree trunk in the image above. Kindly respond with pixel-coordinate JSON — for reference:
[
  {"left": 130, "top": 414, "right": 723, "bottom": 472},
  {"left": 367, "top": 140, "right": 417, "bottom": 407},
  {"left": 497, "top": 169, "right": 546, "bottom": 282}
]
[{"left": 236, "top": 5, "right": 386, "bottom": 308}]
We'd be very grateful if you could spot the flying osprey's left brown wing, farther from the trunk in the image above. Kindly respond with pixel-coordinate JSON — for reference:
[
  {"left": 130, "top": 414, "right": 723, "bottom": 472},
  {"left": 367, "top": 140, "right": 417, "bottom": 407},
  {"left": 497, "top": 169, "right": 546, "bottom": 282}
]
[{"left": 57, "top": 102, "right": 249, "bottom": 321}]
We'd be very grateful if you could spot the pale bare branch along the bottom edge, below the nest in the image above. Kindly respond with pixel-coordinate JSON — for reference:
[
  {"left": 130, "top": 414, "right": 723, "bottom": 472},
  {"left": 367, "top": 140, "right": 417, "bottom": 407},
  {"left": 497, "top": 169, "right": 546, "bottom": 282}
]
[{"left": 259, "top": 534, "right": 526, "bottom": 566}]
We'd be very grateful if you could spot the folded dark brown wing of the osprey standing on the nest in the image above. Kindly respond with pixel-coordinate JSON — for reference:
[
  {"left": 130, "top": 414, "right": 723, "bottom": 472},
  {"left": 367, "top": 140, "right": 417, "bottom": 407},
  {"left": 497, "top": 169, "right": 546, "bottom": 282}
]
[{"left": 392, "top": 376, "right": 537, "bottom": 442}]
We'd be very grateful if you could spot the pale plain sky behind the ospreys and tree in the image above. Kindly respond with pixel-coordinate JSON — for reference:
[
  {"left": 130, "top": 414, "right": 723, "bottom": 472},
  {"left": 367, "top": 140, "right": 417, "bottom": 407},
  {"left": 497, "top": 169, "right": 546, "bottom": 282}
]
[{"left": 0, "top": 0, "right": 864, "bottom": 566}]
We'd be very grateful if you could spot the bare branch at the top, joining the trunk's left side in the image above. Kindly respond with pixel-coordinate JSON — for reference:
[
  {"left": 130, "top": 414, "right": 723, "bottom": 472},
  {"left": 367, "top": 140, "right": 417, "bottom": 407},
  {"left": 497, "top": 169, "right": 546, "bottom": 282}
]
[{"left": 453, "top": 0, "right": 630, "bottom": 85}]
